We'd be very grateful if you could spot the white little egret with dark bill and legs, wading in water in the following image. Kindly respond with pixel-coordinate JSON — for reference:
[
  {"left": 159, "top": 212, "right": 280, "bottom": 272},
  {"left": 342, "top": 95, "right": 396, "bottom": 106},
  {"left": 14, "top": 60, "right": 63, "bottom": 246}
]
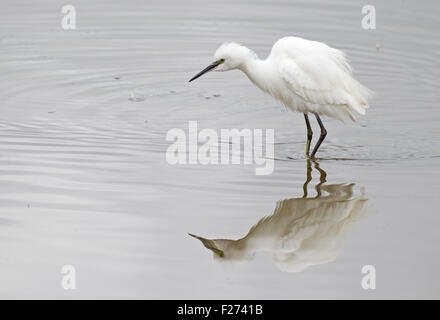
[{"left": 189, "top": 37, "right": 371, "bottom": 158}]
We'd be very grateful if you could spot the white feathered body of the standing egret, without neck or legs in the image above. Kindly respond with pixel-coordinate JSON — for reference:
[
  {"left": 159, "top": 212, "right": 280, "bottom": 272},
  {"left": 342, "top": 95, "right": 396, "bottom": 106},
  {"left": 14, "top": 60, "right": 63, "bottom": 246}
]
[{"left": 274, "top": 37, "right": 371, "bottom": 120}]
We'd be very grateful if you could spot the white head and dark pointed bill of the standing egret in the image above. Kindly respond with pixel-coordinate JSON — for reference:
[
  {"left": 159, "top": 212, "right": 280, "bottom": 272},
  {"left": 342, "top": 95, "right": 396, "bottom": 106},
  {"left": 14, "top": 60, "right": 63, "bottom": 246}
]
[{"left": 189, "top": 42, "right": 256, "bottom": 82}]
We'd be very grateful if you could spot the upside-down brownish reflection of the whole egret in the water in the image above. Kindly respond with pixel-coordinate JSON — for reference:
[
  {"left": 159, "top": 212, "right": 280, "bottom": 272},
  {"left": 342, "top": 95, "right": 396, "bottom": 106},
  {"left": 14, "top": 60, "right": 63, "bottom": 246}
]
[{"left": 190, "top": 161, "right": 366, "bottom": 272}]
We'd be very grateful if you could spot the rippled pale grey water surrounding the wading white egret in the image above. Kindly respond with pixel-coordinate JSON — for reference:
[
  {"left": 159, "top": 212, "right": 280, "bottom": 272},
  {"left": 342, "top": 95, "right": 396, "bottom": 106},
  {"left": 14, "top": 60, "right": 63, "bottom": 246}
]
[{"left": 0, "top": 0, "right": 440, "bottom": 299}]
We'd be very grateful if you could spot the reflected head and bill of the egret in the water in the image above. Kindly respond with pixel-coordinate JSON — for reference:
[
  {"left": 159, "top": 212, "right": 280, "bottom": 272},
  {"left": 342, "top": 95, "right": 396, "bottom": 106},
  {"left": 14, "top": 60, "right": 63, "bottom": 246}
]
[{"left": 189, "top": 233, "right": 254, "bottom": 262}]
